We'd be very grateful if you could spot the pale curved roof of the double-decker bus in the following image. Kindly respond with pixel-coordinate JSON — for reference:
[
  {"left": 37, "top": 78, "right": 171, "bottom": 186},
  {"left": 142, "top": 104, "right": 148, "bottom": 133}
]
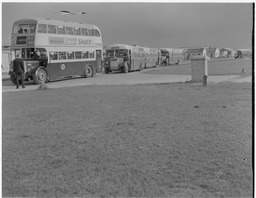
[{"left": 14, "top": 17, "right": 99, "bottom": 30}]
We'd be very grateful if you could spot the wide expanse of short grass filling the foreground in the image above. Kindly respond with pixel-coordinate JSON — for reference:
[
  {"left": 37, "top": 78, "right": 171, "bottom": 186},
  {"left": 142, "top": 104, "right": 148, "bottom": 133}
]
[{"left": 2, "top": 83, "right": 253, "bottom": 197}]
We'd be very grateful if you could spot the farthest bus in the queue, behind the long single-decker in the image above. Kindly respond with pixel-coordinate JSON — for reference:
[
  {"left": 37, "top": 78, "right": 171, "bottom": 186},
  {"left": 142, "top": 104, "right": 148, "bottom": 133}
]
[{"left": 160, "top": 48, "right": 183, "bottom": 65}]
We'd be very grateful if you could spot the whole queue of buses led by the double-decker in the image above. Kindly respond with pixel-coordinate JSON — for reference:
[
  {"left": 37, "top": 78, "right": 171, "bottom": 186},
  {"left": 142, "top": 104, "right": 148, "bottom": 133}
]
[{"left": 10, "top": 18, "right": 185, "bottom": 84}]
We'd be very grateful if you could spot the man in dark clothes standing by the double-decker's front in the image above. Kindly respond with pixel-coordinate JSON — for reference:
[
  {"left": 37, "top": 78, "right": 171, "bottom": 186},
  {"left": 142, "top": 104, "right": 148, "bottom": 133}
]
[{"left": 13, "top": 54, "right": 25, "bottom": 89}]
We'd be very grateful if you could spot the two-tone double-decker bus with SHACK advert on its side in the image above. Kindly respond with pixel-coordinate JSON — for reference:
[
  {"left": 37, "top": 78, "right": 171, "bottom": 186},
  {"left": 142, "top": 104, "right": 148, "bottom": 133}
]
[{"left": 10, "top": 18, "right": 103, "bottom": 84}]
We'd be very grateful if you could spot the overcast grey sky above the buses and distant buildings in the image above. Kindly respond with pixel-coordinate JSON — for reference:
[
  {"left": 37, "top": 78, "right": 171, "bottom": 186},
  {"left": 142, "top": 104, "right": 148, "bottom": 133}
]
[{"left": 2, "top": 2, "right": 252, "bottom": 49}]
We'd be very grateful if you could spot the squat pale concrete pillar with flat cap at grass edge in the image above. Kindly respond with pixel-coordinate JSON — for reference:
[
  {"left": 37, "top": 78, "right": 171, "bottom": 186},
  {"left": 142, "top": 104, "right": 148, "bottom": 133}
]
[{"left": 190, "top": 56, "right": 209, "bottom": 85}]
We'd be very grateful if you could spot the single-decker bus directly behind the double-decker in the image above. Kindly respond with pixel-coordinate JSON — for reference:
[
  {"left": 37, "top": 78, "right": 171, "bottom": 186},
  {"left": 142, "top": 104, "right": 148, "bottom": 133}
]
[{"left": 104, "top": 44, "right": 161, "bottom": 73}]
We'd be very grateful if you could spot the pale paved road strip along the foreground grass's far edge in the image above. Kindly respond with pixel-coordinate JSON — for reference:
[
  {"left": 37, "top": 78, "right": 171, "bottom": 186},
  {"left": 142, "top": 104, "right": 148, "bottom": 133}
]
[{"left": 2, "top": 68, "right": 252, "bottom": 92}]
